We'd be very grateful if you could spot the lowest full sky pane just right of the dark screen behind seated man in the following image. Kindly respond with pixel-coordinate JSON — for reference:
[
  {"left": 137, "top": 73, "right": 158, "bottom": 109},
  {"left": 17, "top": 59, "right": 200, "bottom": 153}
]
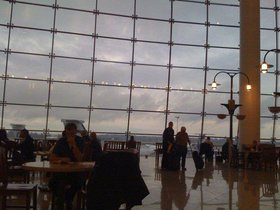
[{"left": 90, "top": 110, "right": 127, "bottom": 133}]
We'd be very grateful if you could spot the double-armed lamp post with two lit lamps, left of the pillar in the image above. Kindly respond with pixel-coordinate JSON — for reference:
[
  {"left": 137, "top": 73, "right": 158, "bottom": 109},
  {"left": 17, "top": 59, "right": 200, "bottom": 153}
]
[{"left": 209, "top": 71, "right": 252, "bottom": 163}]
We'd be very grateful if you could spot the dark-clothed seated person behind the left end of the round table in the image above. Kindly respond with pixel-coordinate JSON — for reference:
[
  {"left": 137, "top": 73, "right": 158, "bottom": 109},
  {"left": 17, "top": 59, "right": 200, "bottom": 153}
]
[{"left": 13, "top": 129, "right": 36, "bottom": 164}]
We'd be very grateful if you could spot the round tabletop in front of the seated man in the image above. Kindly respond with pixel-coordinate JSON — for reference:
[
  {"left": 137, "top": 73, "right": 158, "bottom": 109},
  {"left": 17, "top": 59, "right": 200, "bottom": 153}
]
[{"left": 22, "top": 161, "right": 95, "bottom": 172}]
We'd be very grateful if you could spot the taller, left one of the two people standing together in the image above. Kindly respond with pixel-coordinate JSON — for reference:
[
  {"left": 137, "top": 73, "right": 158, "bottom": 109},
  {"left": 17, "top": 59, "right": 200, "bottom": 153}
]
[{"left": 161, "top": 121, "right": 174, "bottom": 169}]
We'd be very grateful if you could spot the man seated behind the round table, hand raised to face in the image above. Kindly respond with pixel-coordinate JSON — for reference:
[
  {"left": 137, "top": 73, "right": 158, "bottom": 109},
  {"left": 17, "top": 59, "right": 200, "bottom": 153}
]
[{"left": 49, "top": 123, "right": 84, "bottom": 210}]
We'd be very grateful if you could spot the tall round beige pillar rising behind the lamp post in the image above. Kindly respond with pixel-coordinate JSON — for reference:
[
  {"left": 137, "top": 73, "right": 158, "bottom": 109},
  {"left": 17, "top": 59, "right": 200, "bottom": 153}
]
[{"left": 239, "top": 0, "right": 260, "bottom": 145}]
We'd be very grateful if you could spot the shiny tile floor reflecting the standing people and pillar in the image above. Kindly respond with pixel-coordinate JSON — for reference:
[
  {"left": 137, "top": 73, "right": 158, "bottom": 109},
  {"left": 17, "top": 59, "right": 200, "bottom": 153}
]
[{"left": 4, "top": 157, "right": 280, "bottom": 210}]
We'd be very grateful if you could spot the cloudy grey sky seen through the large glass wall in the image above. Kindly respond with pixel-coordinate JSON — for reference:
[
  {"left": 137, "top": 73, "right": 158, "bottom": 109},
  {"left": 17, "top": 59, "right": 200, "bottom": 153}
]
[{"left": 0, "top": 0, "right": 280, "bottom": 141}]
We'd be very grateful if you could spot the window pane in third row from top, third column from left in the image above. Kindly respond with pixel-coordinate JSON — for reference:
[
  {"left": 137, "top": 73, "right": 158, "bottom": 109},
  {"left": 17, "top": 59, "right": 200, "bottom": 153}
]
[{"left": 54, "top": 33, "right": 93, "bottom": 59}]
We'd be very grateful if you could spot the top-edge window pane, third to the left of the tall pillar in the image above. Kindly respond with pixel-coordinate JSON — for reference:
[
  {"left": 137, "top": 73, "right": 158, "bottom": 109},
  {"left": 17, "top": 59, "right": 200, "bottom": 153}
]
[{"left": 136, "top": 0, "right": 171, "bottom": 20}]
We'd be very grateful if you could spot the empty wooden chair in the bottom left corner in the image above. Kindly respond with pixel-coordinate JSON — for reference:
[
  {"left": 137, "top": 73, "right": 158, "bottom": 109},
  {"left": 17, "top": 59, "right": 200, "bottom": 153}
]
[{"left": 0, "top": 147, "right": 37, "bottom": 210}]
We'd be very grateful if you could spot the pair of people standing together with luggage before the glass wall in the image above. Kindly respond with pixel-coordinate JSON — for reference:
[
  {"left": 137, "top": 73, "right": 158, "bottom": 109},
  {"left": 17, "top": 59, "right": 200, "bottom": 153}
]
[{"left": 161, "top": 121, "right": 190, "bottom": 171}]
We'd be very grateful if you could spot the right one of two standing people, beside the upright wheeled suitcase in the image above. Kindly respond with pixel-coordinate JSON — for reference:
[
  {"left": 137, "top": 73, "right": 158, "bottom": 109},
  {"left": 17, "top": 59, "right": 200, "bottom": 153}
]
[{"left": 175, "top": 126, "right": 190, "bottom": 171}]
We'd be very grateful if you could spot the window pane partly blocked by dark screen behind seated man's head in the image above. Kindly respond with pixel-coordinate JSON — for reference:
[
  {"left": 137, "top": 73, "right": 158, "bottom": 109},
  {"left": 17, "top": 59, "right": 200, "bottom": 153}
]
[{"left": 48, "top": 107, "right": 89, "bottom": 131}]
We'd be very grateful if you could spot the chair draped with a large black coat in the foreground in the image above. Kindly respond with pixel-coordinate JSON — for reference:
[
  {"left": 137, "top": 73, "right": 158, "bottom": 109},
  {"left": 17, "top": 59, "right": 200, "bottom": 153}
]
[{"left": 86, "top": 151, "right": 149, "bottom": 209}]
